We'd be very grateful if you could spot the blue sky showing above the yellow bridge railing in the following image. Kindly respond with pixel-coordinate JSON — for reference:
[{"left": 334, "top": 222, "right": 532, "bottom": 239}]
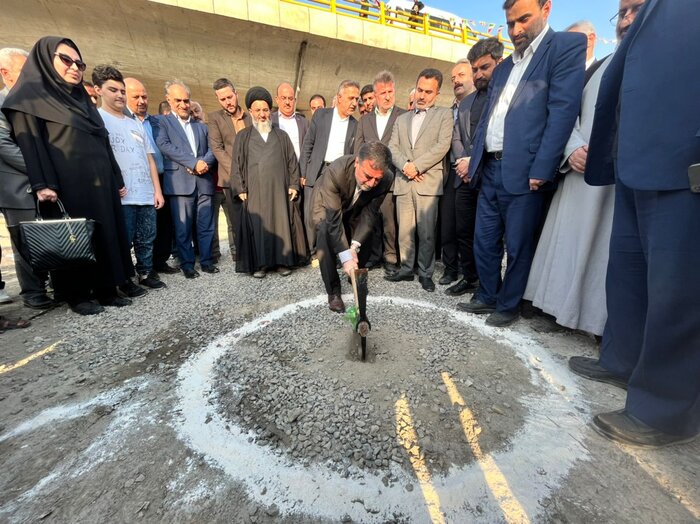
[{"left": 423, "top": 0, "right": 619, "bottom": 58}]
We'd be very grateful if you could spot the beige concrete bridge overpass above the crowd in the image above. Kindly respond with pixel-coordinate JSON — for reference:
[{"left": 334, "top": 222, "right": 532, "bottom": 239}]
[{"left": 0, "top": 0, "right": 492, "bottom": 112}]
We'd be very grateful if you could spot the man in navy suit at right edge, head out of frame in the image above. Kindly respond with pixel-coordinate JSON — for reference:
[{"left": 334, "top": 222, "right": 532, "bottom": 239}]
[{"left": 569, "top": 0, "right": 700, "bottom": 446}]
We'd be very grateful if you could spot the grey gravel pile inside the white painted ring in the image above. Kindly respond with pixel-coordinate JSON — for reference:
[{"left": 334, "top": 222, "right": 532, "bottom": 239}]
[{"left": 215, "top": 291, "right": 535, "bottom": 476}]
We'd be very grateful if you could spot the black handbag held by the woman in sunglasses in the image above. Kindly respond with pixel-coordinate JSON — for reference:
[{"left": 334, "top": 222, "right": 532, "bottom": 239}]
[{"left": 18, "top": 200, "right": 96, "bottom": 271}]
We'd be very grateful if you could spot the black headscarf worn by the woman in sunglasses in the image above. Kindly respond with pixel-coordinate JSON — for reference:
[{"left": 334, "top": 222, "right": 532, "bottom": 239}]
[{"left": 2, "top": 36, "right": 107, "bottom": 136}]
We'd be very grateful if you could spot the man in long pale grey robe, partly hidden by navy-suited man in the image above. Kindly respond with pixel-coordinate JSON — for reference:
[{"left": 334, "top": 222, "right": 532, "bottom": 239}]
[{"left": 524, "top": 0, "right": 643, "bottom": 336}]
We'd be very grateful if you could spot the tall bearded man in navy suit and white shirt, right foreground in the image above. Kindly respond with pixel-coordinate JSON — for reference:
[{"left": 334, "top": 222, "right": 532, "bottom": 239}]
[{"left": 458, "top": 0, "right": 586, "bottom": 327}]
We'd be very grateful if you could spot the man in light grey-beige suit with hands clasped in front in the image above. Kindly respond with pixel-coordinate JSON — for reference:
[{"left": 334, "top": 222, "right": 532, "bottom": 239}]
[{"left": 384, "top": 69, "right": 454, "bottom": 291}]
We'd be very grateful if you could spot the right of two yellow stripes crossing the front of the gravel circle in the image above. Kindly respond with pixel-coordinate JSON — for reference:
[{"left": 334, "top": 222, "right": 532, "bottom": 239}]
[{"left": 442, "top": 372, "right": 530, "bottom": 524}]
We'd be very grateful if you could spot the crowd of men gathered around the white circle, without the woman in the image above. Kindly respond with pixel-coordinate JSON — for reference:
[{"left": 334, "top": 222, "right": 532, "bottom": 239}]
[{"left": 0, "top": 0, "right": 700, "bottom": 446}]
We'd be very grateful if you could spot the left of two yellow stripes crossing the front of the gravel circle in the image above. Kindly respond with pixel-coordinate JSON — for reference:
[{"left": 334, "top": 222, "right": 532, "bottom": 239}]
[{"left": 394, "top": 395, "right": 445, "bottom": 524}]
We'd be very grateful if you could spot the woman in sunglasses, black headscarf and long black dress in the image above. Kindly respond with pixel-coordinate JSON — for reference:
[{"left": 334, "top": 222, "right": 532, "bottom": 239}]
[{"left": 3, "top": 36, "right": 134, "bottom": 315}]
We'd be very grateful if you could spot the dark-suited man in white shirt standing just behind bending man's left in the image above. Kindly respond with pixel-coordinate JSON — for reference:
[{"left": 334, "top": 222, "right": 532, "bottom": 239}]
[{"left": 299, "top": 80, "right": 360, "bottom": 252}]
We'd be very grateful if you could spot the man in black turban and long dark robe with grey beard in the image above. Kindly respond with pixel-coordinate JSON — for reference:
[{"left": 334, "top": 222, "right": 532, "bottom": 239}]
[{"left": 231, "top": 86, "right": 306, "bottom": 278}]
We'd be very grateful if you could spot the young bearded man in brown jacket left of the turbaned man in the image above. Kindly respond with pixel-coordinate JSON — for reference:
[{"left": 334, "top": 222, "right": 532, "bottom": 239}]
[{"left": 208, "top": 78, "right": 252, "bottom": 260}]
